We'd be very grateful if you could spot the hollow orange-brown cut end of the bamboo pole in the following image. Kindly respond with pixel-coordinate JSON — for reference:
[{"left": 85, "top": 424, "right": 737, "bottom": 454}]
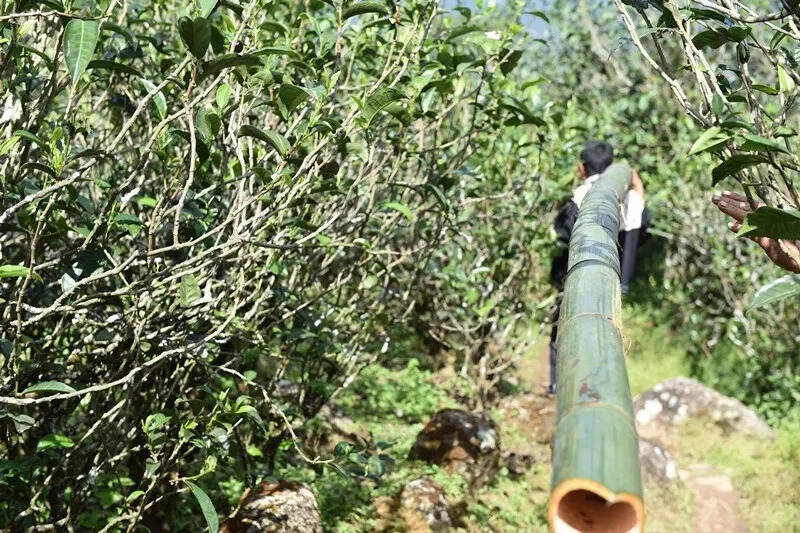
[{"left": 547, "top": 478, "right": 644, "bottom": 533}]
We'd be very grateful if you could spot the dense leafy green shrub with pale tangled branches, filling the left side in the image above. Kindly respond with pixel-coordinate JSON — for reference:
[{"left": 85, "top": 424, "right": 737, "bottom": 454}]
[{"left": 0, "top": 0, "right": 547, "bottom": 530}]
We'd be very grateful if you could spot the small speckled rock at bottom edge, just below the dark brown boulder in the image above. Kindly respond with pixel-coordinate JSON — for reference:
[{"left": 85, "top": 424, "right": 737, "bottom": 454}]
[{"left": 399, "top": 477, "right": 453, "bottom": 532}]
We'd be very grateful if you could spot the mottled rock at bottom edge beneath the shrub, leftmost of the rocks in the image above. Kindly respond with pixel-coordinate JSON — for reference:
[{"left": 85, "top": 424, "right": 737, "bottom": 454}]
[{"left": 220, "top": 480, "right": 322, "bottom": 533}]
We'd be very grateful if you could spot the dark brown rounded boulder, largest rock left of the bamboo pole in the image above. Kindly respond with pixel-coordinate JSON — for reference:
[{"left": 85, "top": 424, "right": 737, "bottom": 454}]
[{"left": 408, "top": 409, "right": 500, "bottom": 488}]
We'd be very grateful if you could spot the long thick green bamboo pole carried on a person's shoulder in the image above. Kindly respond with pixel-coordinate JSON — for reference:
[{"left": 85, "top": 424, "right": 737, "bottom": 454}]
[{"left": 547, "top": 163, "right": 644, "bottom": 533}]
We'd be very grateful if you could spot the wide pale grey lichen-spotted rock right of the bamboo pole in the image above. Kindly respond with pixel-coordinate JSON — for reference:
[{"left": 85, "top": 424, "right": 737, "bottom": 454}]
[{"left": 633, "top": 377, "right": 773, "bottom": 437}]
